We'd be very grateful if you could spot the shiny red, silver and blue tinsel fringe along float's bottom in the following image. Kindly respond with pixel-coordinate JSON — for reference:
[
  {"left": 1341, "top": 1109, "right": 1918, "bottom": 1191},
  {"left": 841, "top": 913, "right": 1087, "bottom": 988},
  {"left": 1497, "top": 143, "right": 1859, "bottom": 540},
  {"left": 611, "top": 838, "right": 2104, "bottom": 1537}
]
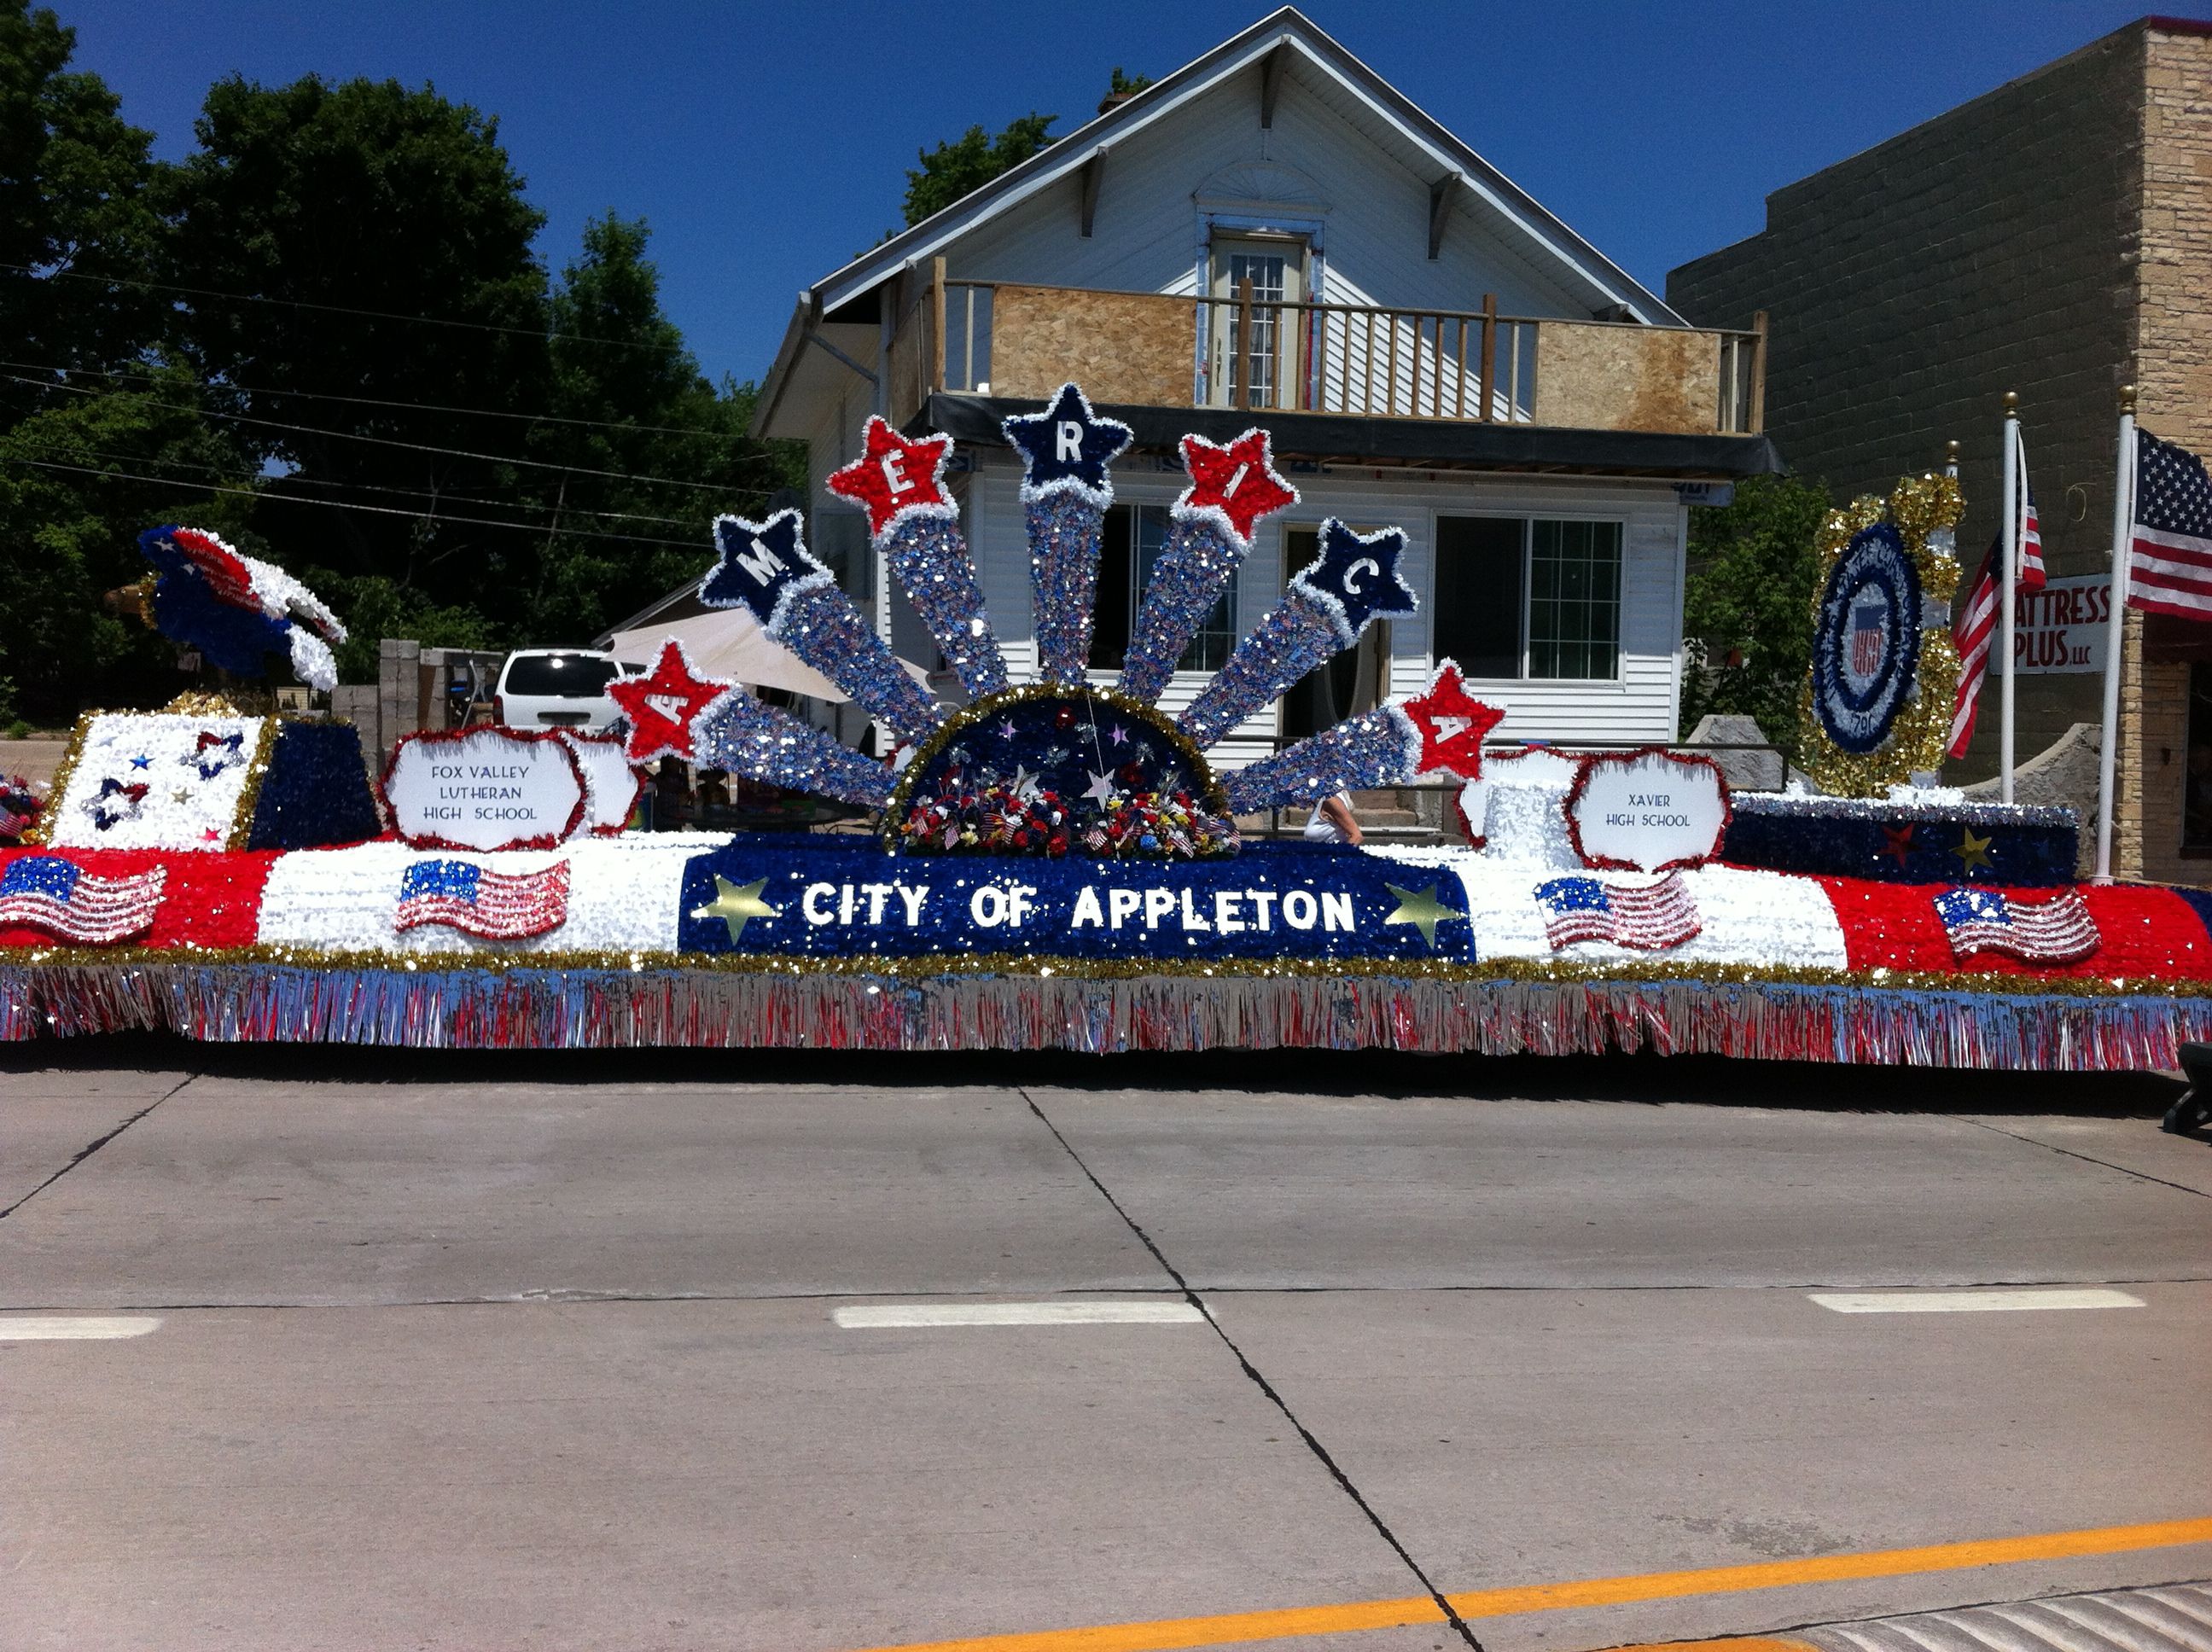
[{"left": 0, "top": 962, "right": 2212, "bottom": 1073}]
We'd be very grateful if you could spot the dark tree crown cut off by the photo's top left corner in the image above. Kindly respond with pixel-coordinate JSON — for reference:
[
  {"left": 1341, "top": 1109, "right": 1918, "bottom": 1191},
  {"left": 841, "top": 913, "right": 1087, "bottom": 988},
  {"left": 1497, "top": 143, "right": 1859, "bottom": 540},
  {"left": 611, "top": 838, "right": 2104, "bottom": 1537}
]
[{"left": 0, "top": 0, "right": 161, "bottom": 404}]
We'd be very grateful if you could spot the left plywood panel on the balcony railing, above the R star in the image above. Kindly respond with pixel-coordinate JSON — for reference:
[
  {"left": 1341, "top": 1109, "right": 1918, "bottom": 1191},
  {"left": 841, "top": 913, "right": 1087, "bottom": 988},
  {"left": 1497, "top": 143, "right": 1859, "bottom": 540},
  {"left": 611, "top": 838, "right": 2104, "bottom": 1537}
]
[{"left": 991, "top": 285, "right": 1192, "bottom": 407}]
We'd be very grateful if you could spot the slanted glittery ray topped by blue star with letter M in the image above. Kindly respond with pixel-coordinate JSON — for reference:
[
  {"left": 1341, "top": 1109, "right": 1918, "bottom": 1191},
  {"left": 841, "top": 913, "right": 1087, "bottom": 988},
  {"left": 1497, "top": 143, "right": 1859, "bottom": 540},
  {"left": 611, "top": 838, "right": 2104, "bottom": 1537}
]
[{"left": 699, "top": 511, "right": 940, "bottom": 741}]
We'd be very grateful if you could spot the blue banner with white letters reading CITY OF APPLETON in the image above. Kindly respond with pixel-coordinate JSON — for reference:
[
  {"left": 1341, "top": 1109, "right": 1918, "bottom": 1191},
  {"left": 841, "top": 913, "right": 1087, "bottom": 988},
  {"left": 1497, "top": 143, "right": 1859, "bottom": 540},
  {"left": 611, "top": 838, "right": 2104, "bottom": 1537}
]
[{"left": 677, "top": 834, "right": 1476, "bottom": 962}]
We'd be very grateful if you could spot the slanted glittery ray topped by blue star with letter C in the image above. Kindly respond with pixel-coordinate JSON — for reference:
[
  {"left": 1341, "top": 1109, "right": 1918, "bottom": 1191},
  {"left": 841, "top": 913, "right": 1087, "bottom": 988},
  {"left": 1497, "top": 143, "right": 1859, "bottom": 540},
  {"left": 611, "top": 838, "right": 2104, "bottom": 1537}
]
[{"left": 1179, "top": 517, "right": 1420, "bottom": 747}]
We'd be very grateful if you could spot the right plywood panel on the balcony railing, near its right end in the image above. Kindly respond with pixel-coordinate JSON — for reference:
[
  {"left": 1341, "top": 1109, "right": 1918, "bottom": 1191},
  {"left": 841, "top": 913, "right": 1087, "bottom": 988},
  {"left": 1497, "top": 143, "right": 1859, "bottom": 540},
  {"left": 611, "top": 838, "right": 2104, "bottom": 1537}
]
[{"left": 1535, "top": 321, "right": 1721, "bottom": 433}]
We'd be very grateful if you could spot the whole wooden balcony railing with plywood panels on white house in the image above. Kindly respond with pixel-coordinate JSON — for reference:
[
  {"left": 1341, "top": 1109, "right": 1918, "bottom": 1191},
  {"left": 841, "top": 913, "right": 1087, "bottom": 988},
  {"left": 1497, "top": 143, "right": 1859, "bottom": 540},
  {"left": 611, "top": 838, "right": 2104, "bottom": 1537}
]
[{"left": 889, "top": 259, "right": 1767, "bottom": 436}]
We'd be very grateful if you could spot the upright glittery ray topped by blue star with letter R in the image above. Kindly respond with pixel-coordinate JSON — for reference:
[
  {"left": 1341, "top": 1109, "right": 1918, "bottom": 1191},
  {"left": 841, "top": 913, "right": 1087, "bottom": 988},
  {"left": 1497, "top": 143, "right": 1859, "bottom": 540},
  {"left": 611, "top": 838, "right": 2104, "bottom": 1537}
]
[{"left": 1000, "top": 382, "right": 1131, "bottom": 688}]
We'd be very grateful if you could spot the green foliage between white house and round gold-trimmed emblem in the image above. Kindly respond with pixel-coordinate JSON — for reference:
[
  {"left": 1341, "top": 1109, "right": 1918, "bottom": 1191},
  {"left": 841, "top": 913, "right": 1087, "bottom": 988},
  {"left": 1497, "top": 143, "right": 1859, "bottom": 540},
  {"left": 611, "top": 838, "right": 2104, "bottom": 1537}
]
[{"left": 1681, "top": 475, "right": 1830, "bottom": 763}]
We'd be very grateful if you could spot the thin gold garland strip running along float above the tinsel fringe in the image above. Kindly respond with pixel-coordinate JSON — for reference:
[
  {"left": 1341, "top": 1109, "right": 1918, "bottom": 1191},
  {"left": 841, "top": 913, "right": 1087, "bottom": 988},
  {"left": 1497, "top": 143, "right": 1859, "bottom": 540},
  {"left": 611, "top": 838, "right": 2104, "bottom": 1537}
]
[{"left": 13, "top": 945, "right": 2212, "bottom": 999}]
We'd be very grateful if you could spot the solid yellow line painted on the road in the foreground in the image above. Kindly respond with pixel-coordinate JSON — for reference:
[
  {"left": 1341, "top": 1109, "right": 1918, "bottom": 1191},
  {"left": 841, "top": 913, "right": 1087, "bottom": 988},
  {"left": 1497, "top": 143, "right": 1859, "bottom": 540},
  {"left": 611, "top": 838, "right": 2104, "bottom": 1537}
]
[{"left": 853, "top": 1519, "right": 2212, "bottom": 1652}]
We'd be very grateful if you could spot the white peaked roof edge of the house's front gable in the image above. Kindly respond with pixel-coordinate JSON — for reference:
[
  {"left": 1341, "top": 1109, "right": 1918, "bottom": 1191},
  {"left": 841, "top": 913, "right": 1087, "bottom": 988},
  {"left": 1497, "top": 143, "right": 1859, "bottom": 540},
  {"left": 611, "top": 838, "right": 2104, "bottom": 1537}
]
[{"left": 803, "top": 7, "right": 1688, "bottom": 328}]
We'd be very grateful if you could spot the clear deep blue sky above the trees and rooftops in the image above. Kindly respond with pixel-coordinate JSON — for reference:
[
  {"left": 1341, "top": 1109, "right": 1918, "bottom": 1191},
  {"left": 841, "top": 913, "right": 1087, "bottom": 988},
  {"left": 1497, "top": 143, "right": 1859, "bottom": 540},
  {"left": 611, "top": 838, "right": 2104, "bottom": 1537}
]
[{"left": 60, "top": 0, "right": 2208, "bottom": 378}]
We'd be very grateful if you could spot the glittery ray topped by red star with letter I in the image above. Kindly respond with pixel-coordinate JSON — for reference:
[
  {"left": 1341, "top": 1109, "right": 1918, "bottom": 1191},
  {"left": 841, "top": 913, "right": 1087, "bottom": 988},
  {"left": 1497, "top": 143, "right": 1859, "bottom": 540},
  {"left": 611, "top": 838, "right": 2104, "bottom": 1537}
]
[{"left": 1117, "top": 429, "right": 1299, "bottom": 701}]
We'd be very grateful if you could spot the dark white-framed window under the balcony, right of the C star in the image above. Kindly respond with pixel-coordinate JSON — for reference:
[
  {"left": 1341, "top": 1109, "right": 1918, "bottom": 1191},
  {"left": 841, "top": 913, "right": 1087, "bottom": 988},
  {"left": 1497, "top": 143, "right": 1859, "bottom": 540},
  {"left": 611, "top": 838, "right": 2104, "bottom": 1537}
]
[{"left": 1431, "top": 515, "right": 1621, "bottom": 681}]
